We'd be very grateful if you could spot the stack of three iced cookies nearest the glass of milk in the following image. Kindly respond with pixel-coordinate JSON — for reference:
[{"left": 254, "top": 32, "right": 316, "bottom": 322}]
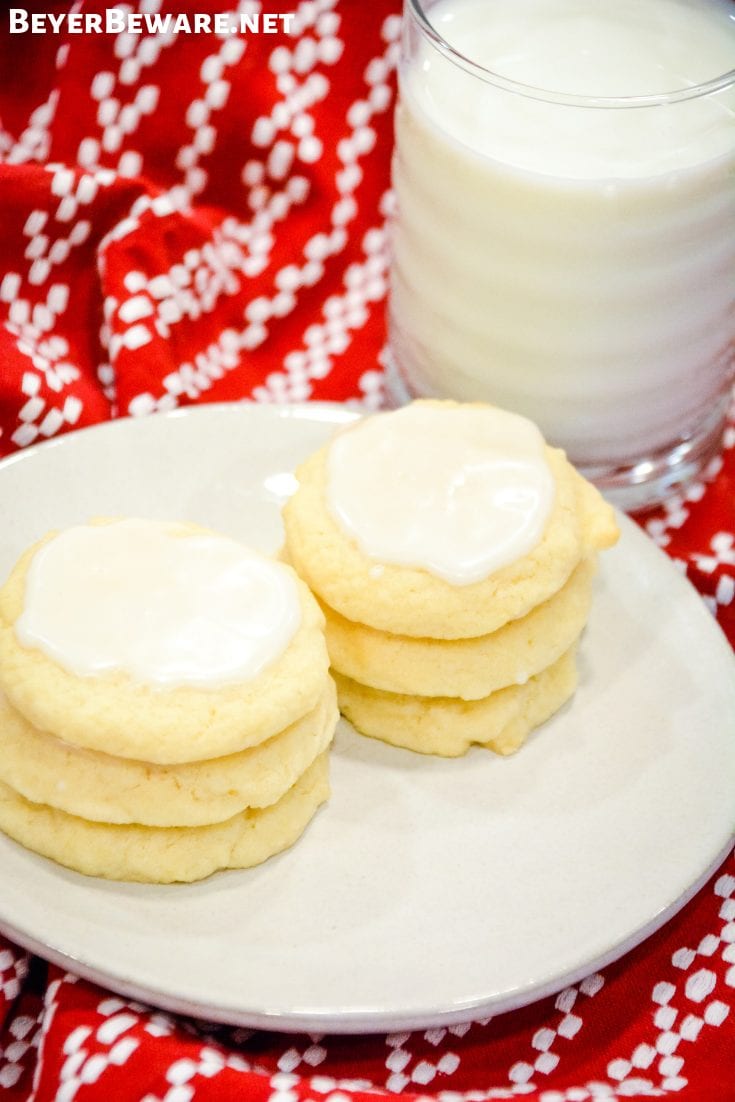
[{"left": 284, "top": 401, "right": 618, "bottom": 756}]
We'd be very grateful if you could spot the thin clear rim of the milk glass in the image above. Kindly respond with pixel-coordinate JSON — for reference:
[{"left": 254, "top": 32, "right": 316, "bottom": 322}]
[{"left": 406, "top": 0, "right": 735, "bottom": 108}]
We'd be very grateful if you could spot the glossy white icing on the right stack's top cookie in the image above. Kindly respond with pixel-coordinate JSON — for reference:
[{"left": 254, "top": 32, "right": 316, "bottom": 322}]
[{"left": 327, "top": 403, "right": 554, "bottom": 585}]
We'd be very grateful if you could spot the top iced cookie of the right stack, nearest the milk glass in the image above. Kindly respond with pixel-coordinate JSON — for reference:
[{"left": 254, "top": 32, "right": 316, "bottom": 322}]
[{"left": 283, "top": 401, "right": 617, "bottom": 639}]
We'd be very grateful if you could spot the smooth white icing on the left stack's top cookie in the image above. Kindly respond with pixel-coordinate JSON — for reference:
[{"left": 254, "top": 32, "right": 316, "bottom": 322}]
[{"left": 15, "top": 520, "right": 301, "bottom": 689}]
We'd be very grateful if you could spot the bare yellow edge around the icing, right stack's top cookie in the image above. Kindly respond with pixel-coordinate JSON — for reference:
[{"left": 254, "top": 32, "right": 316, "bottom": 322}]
[{"left": 283, "top": 402, "right": 618, "bottom": 639}]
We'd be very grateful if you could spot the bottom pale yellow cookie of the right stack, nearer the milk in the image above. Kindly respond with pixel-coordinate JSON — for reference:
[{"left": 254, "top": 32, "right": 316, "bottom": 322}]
[{"left": 336, "top": 648, "right": 576, "bottom": 757}]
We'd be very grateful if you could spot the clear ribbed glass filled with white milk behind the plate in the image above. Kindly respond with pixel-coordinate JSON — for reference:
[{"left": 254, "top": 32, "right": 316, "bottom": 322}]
[{"left": 389, "top": 0, "right": 735, "bottom": 508}]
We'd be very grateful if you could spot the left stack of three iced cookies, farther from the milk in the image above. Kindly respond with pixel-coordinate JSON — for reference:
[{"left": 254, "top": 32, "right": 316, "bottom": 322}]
[{"left": 0, "top": 520, "right": 338, "bottom": 883}]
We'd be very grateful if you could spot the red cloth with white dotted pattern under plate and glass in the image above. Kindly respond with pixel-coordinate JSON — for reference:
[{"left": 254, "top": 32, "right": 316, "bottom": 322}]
[{"left": 0, "top": 0, "right": 735, "bottom": 1102}]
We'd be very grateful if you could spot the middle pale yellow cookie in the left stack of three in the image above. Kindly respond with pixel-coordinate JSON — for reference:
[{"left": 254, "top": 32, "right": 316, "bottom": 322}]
[{"left": 0, "top": 678, "right": 339, "bottom": 827}]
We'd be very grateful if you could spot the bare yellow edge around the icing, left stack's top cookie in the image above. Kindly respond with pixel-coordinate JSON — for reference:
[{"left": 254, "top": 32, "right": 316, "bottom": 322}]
[{"left": 0, "top": 526, "right": 328, "bottom": 765}]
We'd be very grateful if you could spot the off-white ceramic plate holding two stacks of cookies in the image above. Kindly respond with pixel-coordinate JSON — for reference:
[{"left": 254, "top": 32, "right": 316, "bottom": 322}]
[{"left": 0, "top": 404, "right": 735, "bottom": 1033}]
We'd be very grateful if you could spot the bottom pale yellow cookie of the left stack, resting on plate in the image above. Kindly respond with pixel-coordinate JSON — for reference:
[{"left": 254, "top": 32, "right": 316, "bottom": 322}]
[{"left": 0, "top": 753, "right": 329, "bottom": 884}]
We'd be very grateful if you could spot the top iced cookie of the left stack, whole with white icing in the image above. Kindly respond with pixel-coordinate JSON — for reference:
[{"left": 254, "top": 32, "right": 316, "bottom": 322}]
[{"left": 0, "top": 520, "right": 328, "bottom": 765}]
